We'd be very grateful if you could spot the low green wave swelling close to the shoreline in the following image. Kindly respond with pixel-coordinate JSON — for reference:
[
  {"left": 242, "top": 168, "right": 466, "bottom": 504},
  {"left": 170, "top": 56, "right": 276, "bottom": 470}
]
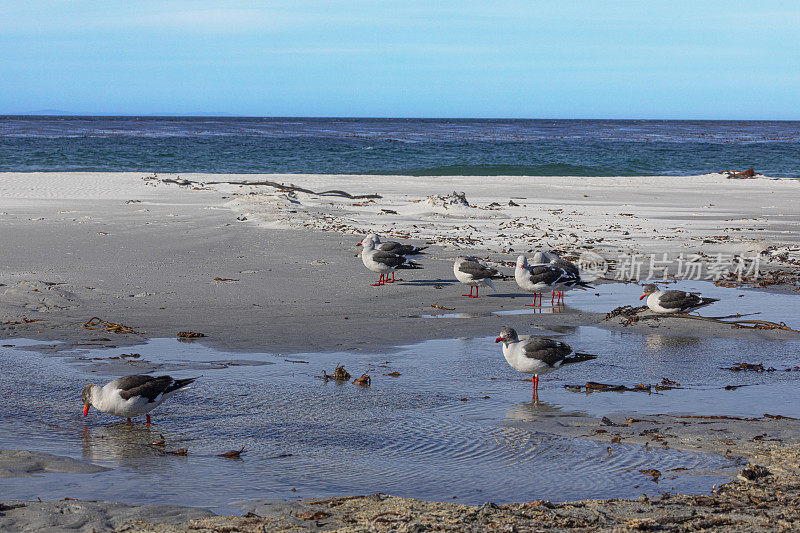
[{"left": 388, "top": 163, "right": 650, "bottom": 176}]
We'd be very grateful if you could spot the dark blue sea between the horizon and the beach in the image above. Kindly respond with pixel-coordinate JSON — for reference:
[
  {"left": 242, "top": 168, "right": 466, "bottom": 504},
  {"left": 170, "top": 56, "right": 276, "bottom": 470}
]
[{"left": 0, "top": 116, "right": 800, "bottom": 178}]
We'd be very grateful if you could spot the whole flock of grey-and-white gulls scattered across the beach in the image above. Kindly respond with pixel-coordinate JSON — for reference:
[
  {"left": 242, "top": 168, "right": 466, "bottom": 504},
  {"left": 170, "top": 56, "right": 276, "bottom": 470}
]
[{"left": 82, "top": 234, "right": 718, "bottom": 425}]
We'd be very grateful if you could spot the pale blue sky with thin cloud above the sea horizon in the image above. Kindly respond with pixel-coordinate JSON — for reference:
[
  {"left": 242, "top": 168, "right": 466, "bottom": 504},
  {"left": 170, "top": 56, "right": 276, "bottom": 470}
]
[{"left": 0, "top": 0, "right": 800, "bottom": 120}]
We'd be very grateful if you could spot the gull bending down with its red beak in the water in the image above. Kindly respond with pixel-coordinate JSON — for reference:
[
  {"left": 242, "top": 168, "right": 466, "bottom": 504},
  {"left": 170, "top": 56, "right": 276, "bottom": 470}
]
[{"left": 81, "top": 375, "right": 197, "bottom": 425}]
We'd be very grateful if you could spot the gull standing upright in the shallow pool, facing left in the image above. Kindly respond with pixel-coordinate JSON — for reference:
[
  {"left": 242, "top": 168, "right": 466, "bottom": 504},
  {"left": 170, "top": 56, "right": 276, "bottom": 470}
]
[{"left": 494, "top": 328, "right": 597, "bottom": 399}]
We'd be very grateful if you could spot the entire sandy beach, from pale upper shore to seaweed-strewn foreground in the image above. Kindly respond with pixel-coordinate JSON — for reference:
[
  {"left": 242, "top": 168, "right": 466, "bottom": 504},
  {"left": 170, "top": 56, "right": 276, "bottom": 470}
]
[{"left": 0, "top": 173, "right": 800, "bottom": 531}]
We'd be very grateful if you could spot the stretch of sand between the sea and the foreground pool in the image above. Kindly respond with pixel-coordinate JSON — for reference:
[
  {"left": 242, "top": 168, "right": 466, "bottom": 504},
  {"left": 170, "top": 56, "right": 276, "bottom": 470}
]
[{"left": 0, "top": 173, "right": 800, "bottom": 351}]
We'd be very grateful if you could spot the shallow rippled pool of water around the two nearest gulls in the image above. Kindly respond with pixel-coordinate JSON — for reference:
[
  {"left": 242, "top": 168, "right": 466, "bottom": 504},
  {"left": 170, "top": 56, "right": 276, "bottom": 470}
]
[{"left": 6, "top": 304, "right": 800, "bottom": 513}]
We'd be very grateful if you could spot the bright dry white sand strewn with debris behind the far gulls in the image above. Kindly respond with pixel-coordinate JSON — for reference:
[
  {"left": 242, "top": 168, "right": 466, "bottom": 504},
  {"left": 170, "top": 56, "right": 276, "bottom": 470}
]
[{"left": 183, "top": 174, "right": 800, "bottom": 255}]
